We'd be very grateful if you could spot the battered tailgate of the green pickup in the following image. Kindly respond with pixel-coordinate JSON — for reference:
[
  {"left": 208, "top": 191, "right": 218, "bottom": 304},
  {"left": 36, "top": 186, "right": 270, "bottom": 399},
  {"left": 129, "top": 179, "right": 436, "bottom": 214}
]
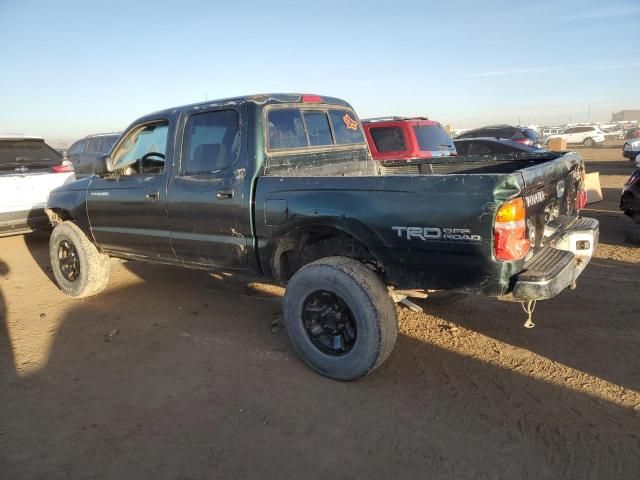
[{"left": 518, "top": 152, "right": 584, "bottom": 251}]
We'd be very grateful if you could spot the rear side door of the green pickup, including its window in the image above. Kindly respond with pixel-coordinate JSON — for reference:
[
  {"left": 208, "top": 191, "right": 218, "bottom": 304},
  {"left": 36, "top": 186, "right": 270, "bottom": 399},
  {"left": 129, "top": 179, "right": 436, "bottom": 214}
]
[{"left": 167, "top": 107, "right": 249, "bottom": 268}]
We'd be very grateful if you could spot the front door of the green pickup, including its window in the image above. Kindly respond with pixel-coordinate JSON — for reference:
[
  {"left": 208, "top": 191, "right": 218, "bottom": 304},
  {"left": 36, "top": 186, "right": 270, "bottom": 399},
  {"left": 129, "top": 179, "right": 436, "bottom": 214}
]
[{"left": 87, "top": 119, "right": 173, "bottom": 258}]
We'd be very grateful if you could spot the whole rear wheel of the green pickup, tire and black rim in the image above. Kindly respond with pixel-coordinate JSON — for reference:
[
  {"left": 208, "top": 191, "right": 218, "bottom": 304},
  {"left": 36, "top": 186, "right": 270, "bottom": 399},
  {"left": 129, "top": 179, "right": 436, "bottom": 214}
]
[{"left": 284, "top": 257, "right": 398, "bottom": 380}]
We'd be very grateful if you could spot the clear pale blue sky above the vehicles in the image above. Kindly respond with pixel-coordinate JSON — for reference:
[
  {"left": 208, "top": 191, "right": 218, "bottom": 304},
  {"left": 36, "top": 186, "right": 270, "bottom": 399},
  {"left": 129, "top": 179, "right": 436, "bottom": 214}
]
[{"left": 0, "top": 0, "right": 640, "bottom": 139}]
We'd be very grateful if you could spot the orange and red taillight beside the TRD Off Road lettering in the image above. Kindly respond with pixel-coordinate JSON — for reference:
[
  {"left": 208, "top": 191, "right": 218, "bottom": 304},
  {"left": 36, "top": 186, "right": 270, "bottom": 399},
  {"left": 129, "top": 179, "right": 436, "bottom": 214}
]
[{"left": 493, "top": 198, "right": 531, "bottom": 261}]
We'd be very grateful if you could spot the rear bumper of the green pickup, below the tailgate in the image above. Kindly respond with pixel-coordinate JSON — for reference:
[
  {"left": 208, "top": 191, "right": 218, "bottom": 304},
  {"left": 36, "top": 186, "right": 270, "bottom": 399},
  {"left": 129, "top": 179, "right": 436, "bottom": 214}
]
[{"left": 511, "top": 218, "right": 600, "bottom": 301}]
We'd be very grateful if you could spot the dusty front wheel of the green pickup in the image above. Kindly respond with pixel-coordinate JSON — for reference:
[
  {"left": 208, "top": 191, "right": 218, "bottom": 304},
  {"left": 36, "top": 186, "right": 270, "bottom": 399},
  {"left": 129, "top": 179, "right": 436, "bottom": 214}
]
[{"left": 49, "top": 222, "right": 110, "bottom": 298}]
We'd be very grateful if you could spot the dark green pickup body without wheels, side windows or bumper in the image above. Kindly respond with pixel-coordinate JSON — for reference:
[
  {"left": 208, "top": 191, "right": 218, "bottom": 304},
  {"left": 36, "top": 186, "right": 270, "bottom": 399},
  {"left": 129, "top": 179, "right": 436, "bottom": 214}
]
[{"left": 48, "top": 94, "right": 596, "bottom": 297}]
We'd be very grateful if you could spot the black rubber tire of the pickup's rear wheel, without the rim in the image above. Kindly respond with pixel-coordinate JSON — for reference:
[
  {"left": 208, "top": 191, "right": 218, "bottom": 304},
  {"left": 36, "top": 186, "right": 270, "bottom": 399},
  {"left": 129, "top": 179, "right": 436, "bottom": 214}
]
[{"left": 283, "top": 257, "right": 398, "bottom": 380}]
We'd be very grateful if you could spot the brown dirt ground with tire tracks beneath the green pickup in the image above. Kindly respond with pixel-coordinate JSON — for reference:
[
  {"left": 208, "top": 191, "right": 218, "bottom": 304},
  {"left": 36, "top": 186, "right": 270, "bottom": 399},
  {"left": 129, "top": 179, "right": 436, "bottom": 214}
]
[{"left": 0, "top": 146, "right": 640, "bottom": 480}]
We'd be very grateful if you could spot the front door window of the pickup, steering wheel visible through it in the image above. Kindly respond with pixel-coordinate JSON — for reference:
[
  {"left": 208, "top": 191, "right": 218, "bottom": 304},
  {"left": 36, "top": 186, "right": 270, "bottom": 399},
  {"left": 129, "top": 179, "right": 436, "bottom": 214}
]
[{"left": 113, "top": 123, "right": 169, "bottom": 175}]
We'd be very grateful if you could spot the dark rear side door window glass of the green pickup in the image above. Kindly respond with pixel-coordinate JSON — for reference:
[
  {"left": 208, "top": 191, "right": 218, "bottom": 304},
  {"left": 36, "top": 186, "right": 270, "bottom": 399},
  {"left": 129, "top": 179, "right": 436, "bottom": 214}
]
[{"left": 182, "top": 110, "right": 239, "bottom": 175}]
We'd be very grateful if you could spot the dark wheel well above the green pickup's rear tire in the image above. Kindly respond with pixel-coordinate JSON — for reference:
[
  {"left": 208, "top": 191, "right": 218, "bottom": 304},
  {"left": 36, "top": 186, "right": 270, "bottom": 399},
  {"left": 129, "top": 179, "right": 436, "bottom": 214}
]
[{"left": 271, "top": 226, "right": 383, "bottom": 283}]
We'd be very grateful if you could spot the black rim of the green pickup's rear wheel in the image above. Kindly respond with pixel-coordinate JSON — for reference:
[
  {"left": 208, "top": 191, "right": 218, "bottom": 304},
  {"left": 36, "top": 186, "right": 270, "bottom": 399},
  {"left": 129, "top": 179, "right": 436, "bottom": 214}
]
[{"left": 302, "top": 290, "right": 358, "bottom": 356}]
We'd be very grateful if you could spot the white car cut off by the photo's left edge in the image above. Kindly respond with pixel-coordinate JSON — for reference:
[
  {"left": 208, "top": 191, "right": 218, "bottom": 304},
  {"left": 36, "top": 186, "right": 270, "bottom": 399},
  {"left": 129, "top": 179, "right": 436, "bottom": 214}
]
[{"left": 0, "top": 136, "right": 75, "bottom": 236}]
